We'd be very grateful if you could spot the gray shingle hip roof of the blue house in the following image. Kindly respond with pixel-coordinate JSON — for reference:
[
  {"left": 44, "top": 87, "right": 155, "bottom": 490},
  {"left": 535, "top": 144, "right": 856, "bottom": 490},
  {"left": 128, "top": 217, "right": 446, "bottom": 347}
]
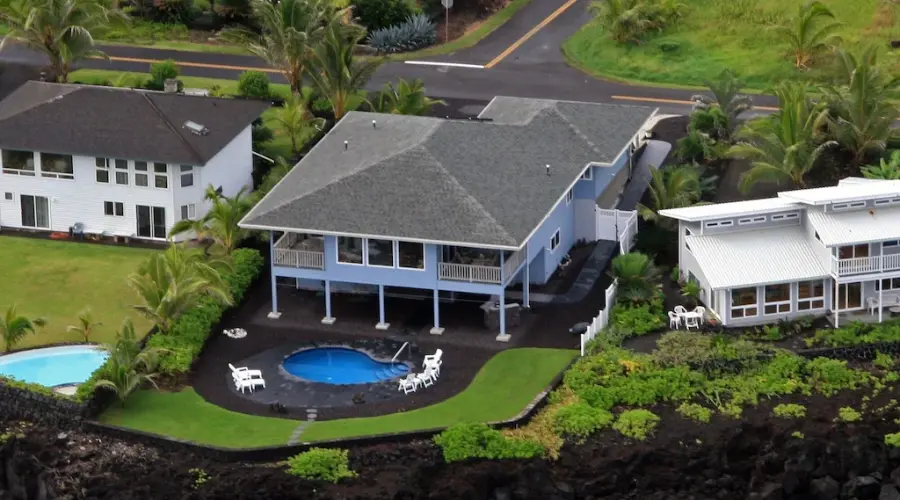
[{"left": 242, "top": 97, "right": 654, "bottom": 247}]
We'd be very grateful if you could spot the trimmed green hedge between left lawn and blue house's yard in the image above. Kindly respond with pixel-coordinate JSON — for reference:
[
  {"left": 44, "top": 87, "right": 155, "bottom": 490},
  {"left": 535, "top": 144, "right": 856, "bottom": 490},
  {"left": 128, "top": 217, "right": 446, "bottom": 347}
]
[{"left": 76, "top": 248, "right": 265, "bottom": 401}]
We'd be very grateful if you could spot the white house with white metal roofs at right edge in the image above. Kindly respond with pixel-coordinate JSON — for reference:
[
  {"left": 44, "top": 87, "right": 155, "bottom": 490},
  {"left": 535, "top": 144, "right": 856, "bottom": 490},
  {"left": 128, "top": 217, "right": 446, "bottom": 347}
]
[{"left": 660, "top": 178, "right": 900, "bottom": 326}]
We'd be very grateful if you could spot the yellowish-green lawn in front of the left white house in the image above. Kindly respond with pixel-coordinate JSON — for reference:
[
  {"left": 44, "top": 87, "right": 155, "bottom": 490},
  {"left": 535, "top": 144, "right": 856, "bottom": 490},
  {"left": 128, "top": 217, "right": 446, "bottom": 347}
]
[{"left": 0, "top": 236, "right": 152, "bottom": 347}]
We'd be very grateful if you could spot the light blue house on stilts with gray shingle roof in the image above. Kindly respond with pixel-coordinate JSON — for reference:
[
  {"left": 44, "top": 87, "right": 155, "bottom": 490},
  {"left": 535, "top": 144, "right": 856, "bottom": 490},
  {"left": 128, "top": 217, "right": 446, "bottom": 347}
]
[{"left": 240, "top": 97, "right": 655, "bottom": 341}]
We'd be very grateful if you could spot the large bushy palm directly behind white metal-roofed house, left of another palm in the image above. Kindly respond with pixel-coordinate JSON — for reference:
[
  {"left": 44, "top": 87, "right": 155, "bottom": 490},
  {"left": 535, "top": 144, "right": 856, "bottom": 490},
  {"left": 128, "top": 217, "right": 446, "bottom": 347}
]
[{"left": 728, "top": 82, "right": 837, "bottom": 193}]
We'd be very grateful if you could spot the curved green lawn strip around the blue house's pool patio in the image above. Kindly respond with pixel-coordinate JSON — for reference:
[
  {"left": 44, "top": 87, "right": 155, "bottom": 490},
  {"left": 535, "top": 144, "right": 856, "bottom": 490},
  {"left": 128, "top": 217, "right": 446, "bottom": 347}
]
[{"left": 100, "top": 348, "right": 577, "bottom": 448}]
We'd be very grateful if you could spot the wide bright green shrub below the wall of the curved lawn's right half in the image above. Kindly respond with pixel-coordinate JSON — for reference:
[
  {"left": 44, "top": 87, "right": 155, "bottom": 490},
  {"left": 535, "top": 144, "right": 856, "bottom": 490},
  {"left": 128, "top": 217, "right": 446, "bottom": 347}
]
[{"left": 434, "top": 423, "right": 546, "bottom": 462}]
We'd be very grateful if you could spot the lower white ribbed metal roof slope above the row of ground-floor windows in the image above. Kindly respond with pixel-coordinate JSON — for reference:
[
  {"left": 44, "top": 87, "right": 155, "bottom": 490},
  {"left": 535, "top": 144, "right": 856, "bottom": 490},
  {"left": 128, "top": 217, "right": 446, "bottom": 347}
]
[{"left": 685, "top": 226, "right": 828, "bottom": 289}]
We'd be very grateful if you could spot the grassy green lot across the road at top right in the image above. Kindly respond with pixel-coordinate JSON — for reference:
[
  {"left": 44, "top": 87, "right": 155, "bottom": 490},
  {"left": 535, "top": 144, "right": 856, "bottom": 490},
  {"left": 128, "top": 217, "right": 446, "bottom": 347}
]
[{"left": 563, "top": 0, "right": 900, "bottom": 89}]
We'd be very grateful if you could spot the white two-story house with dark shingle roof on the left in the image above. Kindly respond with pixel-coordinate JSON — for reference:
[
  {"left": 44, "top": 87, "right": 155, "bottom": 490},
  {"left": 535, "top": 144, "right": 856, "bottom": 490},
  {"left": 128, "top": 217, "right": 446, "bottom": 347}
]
[{"left": 0, "top": 81, "right": 269, "bottom": 240}]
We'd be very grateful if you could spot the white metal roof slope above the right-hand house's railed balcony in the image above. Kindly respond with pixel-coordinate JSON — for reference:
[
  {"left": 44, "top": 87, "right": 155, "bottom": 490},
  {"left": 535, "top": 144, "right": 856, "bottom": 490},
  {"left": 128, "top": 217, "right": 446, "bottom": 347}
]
[{"left": 807, "top": 207, "right": 900, "bottom": 246}]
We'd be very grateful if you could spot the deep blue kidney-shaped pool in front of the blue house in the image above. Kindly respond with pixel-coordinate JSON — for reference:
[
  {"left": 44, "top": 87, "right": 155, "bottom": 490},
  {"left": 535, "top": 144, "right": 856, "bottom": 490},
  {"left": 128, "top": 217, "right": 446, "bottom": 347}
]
[{"left": 284, "top": 347, "right": 409, "bottom": 385}]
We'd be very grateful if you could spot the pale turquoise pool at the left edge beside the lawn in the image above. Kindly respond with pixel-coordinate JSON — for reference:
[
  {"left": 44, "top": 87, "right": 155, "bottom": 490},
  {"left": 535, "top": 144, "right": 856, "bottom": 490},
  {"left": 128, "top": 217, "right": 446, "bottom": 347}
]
[{"left": 0, "top": 345, "right": 107, "bottom": 387}]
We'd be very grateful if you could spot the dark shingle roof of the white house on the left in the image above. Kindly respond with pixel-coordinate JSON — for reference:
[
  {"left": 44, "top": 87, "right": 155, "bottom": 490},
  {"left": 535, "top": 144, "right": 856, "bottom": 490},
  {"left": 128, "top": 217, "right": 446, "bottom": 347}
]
[{"left": 0, "top": 81, "right": 270, "bottom": 165}]
